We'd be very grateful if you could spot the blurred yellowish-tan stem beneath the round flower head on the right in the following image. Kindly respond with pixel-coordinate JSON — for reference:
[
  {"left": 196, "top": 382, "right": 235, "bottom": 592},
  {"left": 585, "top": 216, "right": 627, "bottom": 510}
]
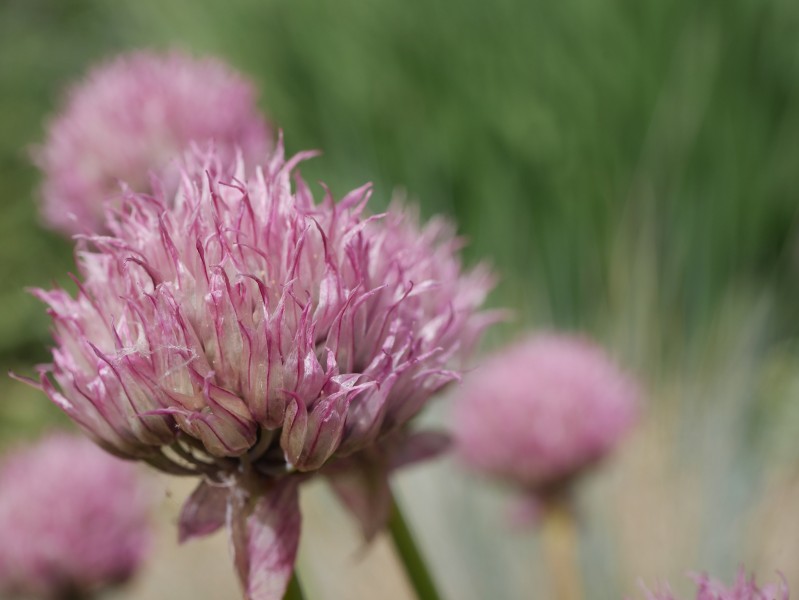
[{"left": 541, "top": 498, "right": 583, "bottom": 600}]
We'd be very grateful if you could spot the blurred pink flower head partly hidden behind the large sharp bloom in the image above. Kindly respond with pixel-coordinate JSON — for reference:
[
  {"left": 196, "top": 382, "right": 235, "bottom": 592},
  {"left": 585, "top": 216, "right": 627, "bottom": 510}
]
[{"left": 36, "top": 52, "right": 272, "bottom": 234}]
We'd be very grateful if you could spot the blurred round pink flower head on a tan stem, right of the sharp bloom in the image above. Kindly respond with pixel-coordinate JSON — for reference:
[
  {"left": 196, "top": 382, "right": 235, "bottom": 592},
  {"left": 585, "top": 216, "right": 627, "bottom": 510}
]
[{"left": 455, "top": 334, "right": 638, "bottom": 493}]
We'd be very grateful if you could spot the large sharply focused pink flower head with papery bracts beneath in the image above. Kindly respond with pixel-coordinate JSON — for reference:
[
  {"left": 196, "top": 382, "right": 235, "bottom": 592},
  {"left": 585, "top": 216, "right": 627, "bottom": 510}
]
[{"left": 26, "top": 144, "right": 490, "bottom": 598}]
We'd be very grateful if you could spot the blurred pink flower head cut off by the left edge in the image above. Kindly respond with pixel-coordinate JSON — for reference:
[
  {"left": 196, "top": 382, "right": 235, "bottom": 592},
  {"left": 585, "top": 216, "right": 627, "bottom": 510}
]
[{"left": 0, "top": 434, "right": 151, "bottom": 598}]
